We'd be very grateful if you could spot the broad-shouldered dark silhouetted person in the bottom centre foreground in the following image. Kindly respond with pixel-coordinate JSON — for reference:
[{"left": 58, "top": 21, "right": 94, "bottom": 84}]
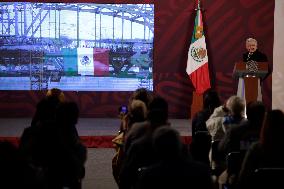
[{"left": 135, "top": 127, "right": 213, "bottom": 189}]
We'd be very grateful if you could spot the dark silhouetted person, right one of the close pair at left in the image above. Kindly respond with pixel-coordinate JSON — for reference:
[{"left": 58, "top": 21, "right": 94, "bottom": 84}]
[{"left": 48, "top": 102, "right": 87, "bottom": 189}]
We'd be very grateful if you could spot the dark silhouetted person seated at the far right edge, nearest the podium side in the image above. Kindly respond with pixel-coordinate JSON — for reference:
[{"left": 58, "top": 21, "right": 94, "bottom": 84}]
[{"left": 238, "top": 110, "right": 284, "bottom": 189}]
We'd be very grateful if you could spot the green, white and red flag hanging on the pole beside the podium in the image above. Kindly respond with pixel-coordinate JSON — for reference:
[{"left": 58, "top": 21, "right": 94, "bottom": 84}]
[{"left": 186, "top": 7, "right": 211, "bottom": 94}]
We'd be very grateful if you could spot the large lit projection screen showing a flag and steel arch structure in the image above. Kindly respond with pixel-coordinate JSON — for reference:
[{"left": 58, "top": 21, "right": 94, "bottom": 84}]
[{"left": 0, "top": 2, "right": 154, "bottom": 91}]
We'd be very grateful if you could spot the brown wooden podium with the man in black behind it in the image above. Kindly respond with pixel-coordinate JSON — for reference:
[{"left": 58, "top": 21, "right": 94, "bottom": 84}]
[{"left": 233, "top": 62, "right": 268, "bottom": 103}]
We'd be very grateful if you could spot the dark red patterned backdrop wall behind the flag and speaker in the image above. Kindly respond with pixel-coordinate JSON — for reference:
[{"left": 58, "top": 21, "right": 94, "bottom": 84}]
[{"left": 0, "top": 0, "right": 275, "bottom": 118}]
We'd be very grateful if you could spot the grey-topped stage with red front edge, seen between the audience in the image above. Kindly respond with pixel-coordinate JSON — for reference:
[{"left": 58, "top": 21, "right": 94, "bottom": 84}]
[{"left": 0, "top": 118, "right": 191, "bottom": 148}]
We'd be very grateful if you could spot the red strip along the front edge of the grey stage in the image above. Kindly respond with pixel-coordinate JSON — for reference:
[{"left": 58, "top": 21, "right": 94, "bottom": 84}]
[{"left": 0, "top": 136, "right": 191, "bottom": 148}]
